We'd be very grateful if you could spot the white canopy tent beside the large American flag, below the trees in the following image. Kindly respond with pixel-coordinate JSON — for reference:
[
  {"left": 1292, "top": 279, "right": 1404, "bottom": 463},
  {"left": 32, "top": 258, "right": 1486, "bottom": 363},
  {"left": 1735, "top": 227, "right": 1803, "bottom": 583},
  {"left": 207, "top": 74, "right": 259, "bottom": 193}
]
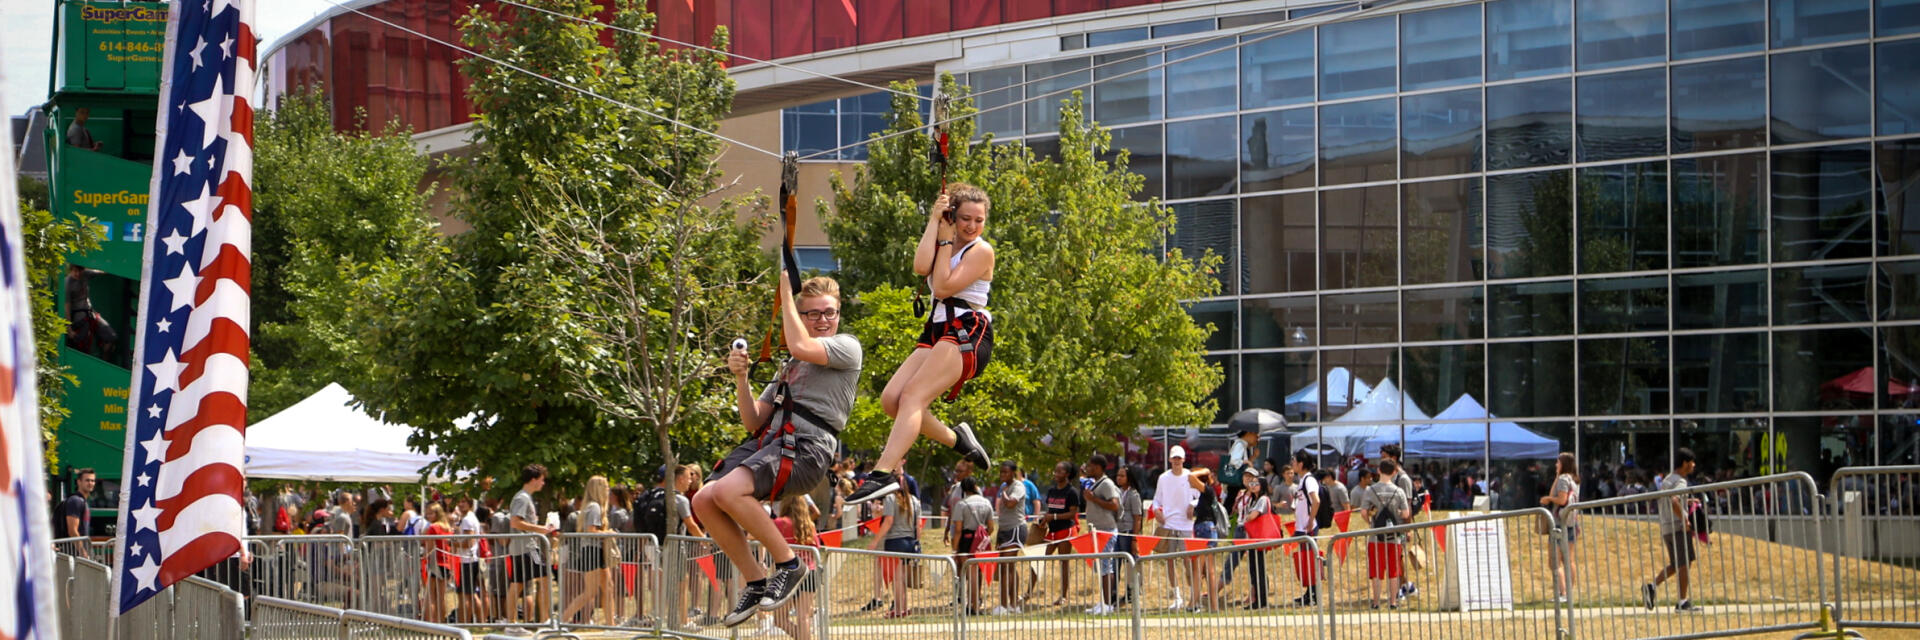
[{"left": 246, "top": 384, "right": 445, "bottom": 484}]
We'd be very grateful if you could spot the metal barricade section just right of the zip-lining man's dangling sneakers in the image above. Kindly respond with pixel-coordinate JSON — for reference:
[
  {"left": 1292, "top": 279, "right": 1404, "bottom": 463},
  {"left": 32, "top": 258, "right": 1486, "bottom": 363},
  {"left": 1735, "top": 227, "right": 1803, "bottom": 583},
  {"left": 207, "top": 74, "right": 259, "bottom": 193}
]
[{"left": 818, "top": 548, "right": 960, "bottom": 638}]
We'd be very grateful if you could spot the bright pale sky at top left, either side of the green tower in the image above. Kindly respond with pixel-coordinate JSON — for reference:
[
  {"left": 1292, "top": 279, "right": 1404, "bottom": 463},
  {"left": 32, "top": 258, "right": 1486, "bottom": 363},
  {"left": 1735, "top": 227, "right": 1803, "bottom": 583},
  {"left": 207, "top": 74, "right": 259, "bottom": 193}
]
[{"left": 0, "top": 0, "right": 332, "bottom": 115}]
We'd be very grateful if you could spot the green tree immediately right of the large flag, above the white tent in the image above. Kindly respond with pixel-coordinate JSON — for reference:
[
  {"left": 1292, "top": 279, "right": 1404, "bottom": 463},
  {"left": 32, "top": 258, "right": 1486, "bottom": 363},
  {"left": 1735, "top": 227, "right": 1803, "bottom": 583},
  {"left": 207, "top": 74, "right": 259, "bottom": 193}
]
[{"left": 248, "top": 92, "right": 434, "bottom": 419}]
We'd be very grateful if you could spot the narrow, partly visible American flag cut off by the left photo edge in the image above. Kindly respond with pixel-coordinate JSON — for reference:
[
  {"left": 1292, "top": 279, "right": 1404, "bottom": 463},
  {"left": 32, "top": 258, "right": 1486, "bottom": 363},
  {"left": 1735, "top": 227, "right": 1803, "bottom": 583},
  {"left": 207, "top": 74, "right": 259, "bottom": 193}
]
[{"left": 0, "top": 67, "right": 60, "bottom": 640}]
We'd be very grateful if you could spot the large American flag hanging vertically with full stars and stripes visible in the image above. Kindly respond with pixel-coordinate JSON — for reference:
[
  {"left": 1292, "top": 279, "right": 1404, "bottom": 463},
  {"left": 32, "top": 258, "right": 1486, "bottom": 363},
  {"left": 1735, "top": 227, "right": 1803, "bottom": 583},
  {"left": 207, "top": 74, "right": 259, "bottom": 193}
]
[{"left": 113, "top": 0, "right": 255, "bottom": 613}]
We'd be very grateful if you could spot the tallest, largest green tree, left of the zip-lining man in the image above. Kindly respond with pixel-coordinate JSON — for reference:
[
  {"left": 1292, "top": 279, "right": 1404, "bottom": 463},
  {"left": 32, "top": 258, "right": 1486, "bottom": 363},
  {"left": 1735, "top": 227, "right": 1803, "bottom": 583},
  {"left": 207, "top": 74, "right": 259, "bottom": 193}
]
[{"left": 341, "top": 0, "right": 766, "bottom": 490}]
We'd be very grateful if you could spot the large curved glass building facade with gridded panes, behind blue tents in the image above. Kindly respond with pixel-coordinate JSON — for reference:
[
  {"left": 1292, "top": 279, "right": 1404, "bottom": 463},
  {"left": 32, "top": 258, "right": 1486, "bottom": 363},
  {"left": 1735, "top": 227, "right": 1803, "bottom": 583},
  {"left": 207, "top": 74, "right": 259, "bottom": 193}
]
[{"left": 917, "top": 0, "right": 1920, "bottom": 505}]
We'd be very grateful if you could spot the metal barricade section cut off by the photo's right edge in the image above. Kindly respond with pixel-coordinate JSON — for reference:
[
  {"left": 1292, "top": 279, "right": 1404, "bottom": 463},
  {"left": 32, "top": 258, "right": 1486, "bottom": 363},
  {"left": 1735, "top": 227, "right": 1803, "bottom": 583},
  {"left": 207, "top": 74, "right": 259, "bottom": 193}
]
[{"left": 1828, "top": 467, "right": 1920, "bottom": 628}]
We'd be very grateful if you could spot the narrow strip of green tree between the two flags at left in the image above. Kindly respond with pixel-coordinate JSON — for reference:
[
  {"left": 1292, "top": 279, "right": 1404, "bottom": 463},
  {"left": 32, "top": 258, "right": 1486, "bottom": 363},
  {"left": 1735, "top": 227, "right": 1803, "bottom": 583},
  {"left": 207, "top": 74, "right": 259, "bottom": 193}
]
[{"left": 19, "top": 192, "right": 102, "bottom": 473}]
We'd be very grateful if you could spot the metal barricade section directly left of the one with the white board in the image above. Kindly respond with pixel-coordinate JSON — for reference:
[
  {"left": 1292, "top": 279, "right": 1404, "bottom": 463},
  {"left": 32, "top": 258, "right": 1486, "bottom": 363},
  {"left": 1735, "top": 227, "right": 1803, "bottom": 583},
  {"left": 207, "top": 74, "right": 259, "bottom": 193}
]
[{"left": 1133, "top": 536, "right": 1325, "bottom": 638}]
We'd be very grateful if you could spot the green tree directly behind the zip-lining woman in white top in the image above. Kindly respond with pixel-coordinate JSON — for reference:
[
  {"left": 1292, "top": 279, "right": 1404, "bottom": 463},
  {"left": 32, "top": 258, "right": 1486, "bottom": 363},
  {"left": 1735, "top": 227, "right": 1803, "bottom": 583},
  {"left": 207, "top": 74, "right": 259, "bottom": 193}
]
[{"left": 820, "top": 77, "right": 1221, "bottom": 465}]
